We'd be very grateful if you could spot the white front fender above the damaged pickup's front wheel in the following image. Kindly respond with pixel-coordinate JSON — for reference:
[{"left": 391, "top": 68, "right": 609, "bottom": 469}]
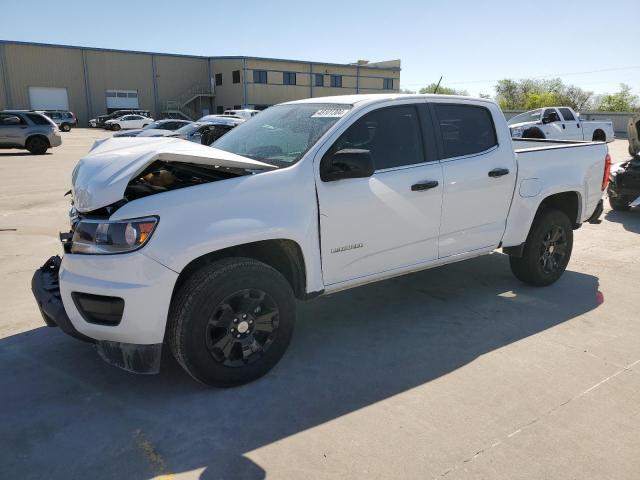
[{"left": 112, "top": 162, "right": 324, "bottom": 292}]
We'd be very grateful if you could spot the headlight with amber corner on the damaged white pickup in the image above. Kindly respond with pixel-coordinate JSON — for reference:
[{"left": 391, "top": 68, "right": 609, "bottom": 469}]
[{"left": 71, "top": 217, "right": 158, "bottom": 254}]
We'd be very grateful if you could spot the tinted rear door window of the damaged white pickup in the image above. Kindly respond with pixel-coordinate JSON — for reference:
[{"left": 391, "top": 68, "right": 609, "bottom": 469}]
[{"left": 434, "top": 103, "right": 498, "bottom": 158}]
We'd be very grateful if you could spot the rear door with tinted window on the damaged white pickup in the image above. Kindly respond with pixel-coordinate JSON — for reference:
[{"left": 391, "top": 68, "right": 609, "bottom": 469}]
[{"left": 430, "top": 102, "right": 516, "bottom": 258}]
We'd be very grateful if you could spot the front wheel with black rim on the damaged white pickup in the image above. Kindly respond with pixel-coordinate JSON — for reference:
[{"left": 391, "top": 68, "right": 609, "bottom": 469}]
[{"left": 167, "top": 257, "right": 296, "bottom": 387}]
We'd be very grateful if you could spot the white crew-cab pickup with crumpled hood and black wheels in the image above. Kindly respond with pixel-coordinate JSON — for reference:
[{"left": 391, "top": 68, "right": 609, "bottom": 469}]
[{"left": 32, "top": 94, "right": 610, "bottom": 386}]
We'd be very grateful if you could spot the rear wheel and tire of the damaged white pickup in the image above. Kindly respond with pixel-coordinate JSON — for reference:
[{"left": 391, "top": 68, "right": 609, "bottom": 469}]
[{"left": 509, "top": 209, "right": 573, "bottom": 287}]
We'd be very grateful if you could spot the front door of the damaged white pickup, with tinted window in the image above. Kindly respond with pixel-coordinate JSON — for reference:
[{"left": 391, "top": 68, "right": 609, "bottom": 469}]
[{"left": 315, "top": 103, "right": 442, "bottom": 285}]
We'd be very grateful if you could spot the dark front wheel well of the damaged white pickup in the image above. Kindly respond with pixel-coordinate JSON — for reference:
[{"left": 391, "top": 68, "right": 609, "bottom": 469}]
[{"left": 173, "top": 239, "right": 307, "bottom": 298}]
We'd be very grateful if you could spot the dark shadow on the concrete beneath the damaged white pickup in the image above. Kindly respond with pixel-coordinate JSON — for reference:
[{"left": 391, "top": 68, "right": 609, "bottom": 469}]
[{"left": 0, "top": 254, "right": 602, "bottom": 479}]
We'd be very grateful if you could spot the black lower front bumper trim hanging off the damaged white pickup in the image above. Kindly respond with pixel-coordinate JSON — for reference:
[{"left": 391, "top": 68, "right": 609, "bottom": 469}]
[{"left": 31, "top": 255, "right": 162, "bottom": 374}]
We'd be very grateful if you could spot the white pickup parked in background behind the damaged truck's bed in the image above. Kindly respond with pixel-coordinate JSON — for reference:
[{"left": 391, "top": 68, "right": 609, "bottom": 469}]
[{"left": 508, "top": 107, "right": 614, "bottom": 142}]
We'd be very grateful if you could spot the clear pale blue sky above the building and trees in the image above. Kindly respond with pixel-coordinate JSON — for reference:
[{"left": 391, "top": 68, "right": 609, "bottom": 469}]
[{"left": 0, "top": 0, "right": 640, "bottom": 96}]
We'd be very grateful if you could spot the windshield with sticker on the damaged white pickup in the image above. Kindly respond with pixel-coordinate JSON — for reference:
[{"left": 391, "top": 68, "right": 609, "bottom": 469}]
[{"left": 213, "top": 103, "right": 351, "bottom": 167}]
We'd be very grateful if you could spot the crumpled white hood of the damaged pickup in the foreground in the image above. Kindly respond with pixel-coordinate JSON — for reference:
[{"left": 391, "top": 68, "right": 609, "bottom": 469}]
[{"left": 72, "top": 137, "right": 276, "bottom": 212}]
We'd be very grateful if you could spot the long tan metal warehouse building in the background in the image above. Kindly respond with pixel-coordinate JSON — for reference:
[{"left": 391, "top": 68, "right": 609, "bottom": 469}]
[{"left": 0, "top": 41, "right": 400, "bottom": 125}]
